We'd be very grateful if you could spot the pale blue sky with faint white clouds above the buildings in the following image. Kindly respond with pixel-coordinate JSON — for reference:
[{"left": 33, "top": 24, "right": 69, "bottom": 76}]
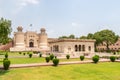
[{"left": 0, "top": 0, "right": 120, "bottom": 38}]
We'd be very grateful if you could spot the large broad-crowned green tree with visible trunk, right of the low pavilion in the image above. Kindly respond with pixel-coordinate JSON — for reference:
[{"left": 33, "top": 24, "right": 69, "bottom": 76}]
[{"left": 94, "top": 29, "right": 119, "bottom": 51}]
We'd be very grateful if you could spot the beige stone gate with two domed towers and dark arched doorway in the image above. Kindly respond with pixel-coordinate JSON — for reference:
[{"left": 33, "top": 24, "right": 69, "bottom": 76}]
[{"left": 10, "top": 26, "right": 49, "bottom": 51}]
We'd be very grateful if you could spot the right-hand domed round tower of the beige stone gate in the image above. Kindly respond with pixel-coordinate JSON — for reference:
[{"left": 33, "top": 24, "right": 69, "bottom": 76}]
[{"left": 39, "top": 28, "right": 48, "bottom": 50}]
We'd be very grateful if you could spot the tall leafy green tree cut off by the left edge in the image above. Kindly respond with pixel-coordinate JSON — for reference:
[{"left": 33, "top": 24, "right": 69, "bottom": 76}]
[{"left": 0, "top": 18, "right": 12, "bottom": 44}]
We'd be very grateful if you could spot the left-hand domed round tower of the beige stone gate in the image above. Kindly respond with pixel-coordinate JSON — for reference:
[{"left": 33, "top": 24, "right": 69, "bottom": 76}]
[{"left": 14, "top": 26, "right": 25, "bottom": 48}]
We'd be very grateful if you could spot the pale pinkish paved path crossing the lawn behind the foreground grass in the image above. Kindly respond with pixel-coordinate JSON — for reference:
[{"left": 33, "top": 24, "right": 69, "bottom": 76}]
[{"left": 0, "top": 59, "right": 120, "bottom": 69}]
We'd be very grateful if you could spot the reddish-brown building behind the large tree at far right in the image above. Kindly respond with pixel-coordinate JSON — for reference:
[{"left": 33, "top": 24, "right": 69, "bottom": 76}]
[{"left": 97, "top": 39, "right": 120, "bottom": 51}]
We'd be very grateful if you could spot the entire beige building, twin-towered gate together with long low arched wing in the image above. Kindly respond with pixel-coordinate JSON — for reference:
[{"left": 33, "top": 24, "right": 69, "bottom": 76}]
[{"left": 10, "top": 26, "right": 95, "bottom": 55}]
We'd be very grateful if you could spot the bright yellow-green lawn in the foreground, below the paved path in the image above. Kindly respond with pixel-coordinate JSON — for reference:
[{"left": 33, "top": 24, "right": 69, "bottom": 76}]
[{"left": 0, "top": 62, "right": 120, "bottom": 80}]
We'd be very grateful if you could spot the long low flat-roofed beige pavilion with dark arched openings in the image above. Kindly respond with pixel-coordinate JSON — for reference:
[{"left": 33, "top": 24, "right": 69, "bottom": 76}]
[{"left": 49, "top": 39, "right": 95, "bottom": 55}]
